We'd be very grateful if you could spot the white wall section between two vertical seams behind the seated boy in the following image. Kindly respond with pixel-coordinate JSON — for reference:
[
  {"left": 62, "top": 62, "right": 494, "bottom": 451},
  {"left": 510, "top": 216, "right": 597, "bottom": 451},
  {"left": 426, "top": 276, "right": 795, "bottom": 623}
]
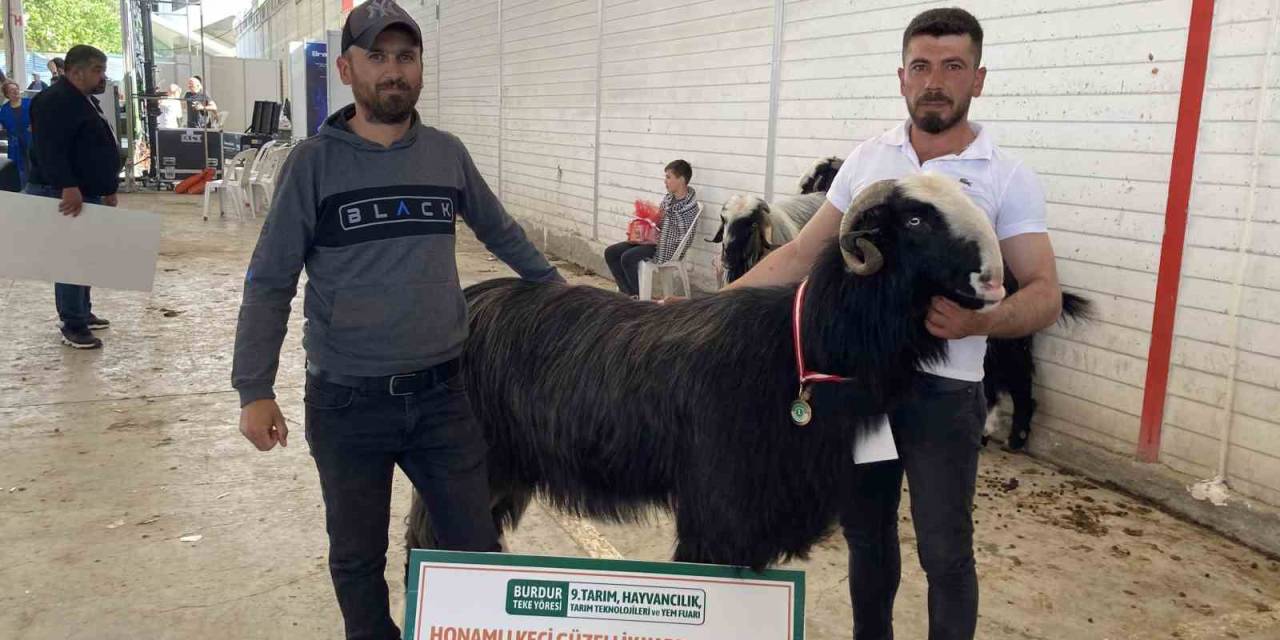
[{"left": 599, "top": 0, "right": 773, "bottom": 282}]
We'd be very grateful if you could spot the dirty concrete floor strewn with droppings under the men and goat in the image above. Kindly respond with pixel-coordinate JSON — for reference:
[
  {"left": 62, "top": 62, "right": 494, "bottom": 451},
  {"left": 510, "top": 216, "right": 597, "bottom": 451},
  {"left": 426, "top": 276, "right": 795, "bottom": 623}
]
[{"left": 0, "top": 195, "right": 1280, "bottom": 640}]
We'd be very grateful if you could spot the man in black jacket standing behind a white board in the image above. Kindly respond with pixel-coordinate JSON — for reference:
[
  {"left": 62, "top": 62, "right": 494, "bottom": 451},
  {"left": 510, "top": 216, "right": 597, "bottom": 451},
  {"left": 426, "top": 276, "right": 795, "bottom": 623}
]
[{"left": 26, "top": 45, "right": 120, "bottom": 349}]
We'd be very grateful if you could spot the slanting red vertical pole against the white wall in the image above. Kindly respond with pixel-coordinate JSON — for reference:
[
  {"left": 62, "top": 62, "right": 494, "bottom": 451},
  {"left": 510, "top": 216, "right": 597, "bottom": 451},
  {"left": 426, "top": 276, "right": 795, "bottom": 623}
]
[{"left": 1138, "top": 0, "right": 1213, "bottom": 462}]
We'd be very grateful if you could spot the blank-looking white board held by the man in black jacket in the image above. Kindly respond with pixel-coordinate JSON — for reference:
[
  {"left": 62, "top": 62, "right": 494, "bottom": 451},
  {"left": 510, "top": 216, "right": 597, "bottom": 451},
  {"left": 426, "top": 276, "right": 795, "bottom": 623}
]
[{"left": 0, "top": 192, "right": 160, "bottom": 291}]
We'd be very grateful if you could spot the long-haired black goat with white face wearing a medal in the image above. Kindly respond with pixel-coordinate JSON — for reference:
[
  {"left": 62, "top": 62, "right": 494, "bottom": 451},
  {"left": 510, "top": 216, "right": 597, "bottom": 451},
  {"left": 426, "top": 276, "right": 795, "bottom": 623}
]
[{"left": 406, "top": 175, "right": 1004, "bottom": 568}]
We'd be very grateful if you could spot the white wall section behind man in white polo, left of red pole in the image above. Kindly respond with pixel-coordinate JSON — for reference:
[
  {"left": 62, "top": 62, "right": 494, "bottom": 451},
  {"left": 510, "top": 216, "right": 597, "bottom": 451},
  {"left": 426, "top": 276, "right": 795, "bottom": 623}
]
[{"left": 776, "top": 0, "right": 1190, "bottom": 478}]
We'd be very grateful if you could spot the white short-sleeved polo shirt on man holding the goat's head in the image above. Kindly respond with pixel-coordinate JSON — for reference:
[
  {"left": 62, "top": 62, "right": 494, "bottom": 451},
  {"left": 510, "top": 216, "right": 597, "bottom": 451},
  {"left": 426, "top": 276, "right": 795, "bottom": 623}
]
[{"left": 827, "top": 122, "right": 1047, "bottom": 381}]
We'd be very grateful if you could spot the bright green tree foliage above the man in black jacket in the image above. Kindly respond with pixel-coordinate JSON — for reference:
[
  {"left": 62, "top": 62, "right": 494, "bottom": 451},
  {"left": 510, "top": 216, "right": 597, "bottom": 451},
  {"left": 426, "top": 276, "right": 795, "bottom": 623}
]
[{"left": 23, "top": 0, "right": 123, "bottom": 54}]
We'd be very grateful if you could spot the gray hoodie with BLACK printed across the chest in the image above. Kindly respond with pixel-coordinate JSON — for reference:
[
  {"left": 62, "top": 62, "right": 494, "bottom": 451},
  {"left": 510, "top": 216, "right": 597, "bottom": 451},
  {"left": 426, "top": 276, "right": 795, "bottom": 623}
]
[{"left": 232, "top": 106, "right": 563, "bottom": 406}]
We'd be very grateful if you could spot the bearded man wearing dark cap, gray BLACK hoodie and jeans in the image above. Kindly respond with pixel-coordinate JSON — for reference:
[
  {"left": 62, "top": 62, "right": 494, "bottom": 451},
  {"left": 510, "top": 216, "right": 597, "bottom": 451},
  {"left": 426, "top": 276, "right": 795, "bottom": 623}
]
[{"left": 232, "top": 0, "right": 563, "bottom": 640}]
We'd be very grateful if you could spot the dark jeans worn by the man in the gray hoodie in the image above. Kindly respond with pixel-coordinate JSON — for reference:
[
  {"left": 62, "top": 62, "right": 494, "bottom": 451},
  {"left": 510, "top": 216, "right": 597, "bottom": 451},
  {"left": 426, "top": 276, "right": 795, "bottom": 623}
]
[{"left": 306, "top": 375, "right": 499, "bottom": 640}]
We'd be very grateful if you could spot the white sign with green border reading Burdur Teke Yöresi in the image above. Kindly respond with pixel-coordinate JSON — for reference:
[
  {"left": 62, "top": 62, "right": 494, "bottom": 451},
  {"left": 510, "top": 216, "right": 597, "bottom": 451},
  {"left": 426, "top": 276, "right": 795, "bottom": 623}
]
[{"left": 404, "top": 549, "right": 804, "bottom": 640}]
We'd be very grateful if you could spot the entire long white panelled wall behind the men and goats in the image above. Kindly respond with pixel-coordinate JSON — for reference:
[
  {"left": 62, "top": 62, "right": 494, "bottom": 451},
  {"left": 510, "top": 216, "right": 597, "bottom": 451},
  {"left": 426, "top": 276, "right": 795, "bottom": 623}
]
[{"left": 242, "top": 0, "right": 1280, "bottom": 506}]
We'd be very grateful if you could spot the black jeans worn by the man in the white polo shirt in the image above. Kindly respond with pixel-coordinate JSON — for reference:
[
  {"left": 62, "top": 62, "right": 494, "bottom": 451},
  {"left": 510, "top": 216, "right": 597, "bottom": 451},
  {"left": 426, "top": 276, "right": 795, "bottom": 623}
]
[{"left": 841, "top": 374, "right": 987, "bottom": 640}]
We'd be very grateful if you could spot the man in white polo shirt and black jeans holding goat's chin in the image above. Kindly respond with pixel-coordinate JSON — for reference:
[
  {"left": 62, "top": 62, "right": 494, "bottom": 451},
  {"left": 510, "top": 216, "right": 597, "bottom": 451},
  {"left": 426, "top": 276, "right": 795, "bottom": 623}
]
[{"left": 731, "top": 9, "right": 1062, "bottom": 640}]
